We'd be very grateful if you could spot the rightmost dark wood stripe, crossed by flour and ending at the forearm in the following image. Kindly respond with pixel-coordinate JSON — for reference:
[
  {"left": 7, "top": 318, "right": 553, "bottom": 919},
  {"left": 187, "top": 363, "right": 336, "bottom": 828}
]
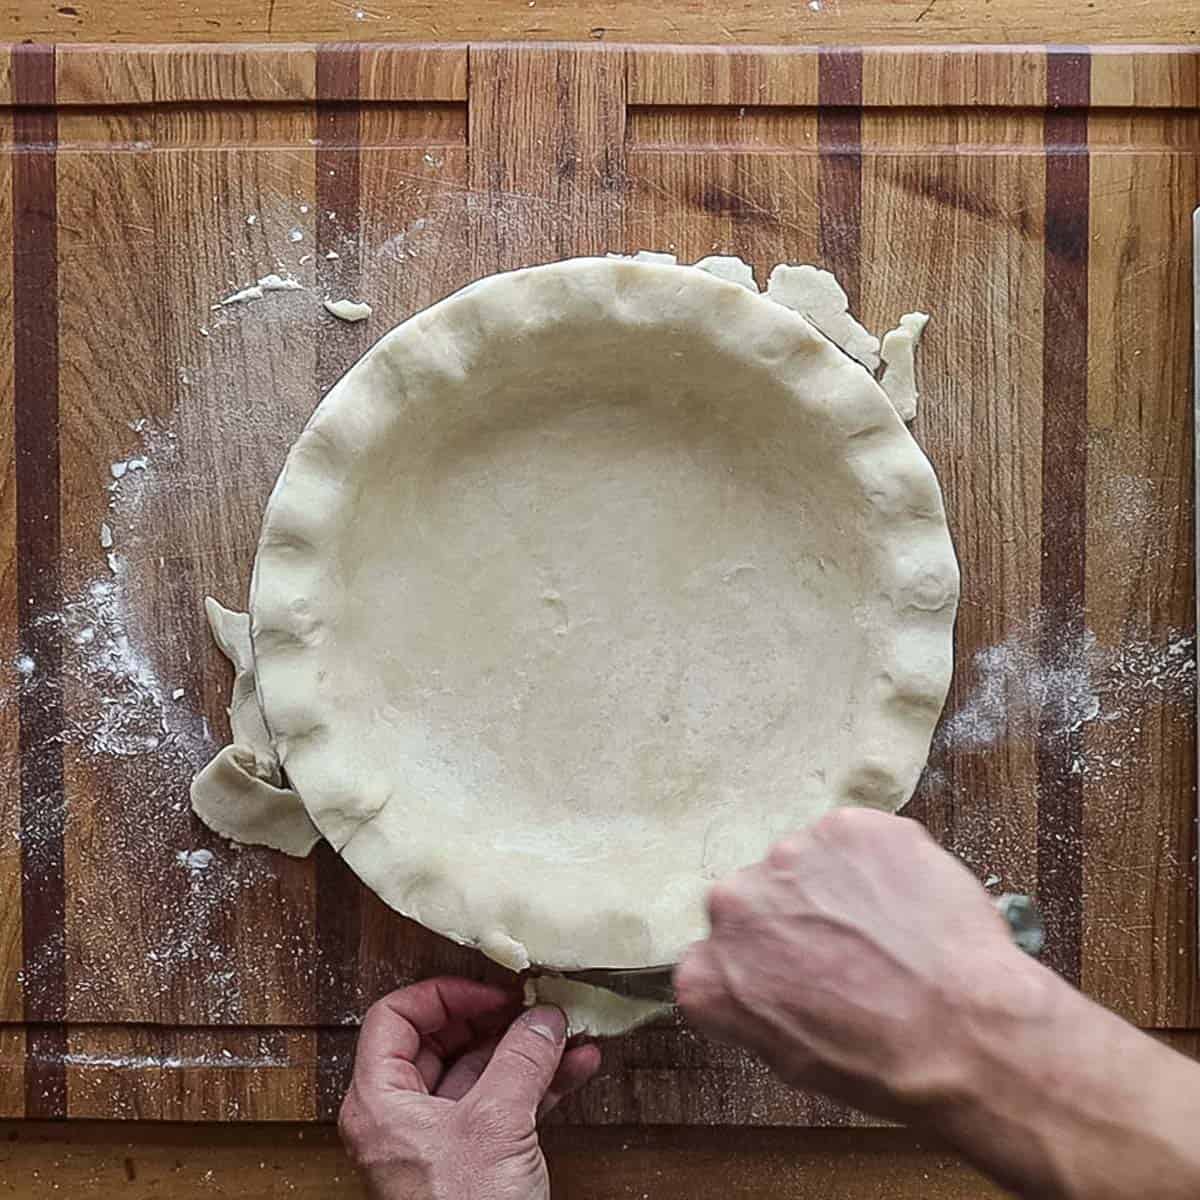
[{"left": 1037, "top": 50, "right": 1091, "bottom": 984}]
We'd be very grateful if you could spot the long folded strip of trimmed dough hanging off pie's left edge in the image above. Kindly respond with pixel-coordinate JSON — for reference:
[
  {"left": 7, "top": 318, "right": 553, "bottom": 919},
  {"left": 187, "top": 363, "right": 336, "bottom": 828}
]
[{"left": 191, "top": 596, "right": 320, "bottom": 858}]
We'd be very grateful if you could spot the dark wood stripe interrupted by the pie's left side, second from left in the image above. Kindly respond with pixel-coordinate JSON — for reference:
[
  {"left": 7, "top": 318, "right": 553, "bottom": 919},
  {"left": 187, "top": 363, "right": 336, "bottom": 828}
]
[{"left": 316, "top": 39, "right": 367, "bottom": 1121}]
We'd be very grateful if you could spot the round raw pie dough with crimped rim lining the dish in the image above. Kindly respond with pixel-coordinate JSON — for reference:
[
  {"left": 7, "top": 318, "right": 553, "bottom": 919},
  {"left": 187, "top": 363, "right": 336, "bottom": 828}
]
[{"left": 193, "top": 258, "right": 958, "bottom": 1028}]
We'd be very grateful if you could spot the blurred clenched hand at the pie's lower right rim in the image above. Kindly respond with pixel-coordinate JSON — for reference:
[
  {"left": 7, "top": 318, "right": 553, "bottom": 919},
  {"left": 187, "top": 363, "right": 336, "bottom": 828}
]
[{"left": 676, "top": 809, "right": 1055, "bottom": 1120}]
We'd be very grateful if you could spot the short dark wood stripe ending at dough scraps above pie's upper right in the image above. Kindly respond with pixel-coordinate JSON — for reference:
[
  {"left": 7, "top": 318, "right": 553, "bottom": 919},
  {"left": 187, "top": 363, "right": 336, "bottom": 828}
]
[{"left": 817, "top": 49, "right": 863, "bottom": 308}]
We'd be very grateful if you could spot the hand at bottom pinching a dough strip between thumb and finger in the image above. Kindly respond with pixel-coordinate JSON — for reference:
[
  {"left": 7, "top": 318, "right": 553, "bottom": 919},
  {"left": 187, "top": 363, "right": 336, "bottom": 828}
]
[{"left": 338, "top": 978, "right": 600, "bottom": 1200}]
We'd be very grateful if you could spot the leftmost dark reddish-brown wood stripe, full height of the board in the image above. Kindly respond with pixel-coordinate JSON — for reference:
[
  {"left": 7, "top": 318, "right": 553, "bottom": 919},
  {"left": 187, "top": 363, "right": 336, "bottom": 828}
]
[{"left": 12, "top": 46, "right": 66, "bottom": 1117}]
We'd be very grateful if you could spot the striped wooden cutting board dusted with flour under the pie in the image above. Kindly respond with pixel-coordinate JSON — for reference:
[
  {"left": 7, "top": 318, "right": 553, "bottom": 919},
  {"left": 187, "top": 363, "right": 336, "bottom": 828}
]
[{"left": 0, "top": 39, "right": 1200, "bottom": 1124}]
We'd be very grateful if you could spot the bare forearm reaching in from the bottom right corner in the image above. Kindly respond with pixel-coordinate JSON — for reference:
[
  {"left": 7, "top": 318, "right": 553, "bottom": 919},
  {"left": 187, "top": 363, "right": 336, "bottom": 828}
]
[{"left": 934, "top": 965, "right": 1200, "bottom": 1200}]
